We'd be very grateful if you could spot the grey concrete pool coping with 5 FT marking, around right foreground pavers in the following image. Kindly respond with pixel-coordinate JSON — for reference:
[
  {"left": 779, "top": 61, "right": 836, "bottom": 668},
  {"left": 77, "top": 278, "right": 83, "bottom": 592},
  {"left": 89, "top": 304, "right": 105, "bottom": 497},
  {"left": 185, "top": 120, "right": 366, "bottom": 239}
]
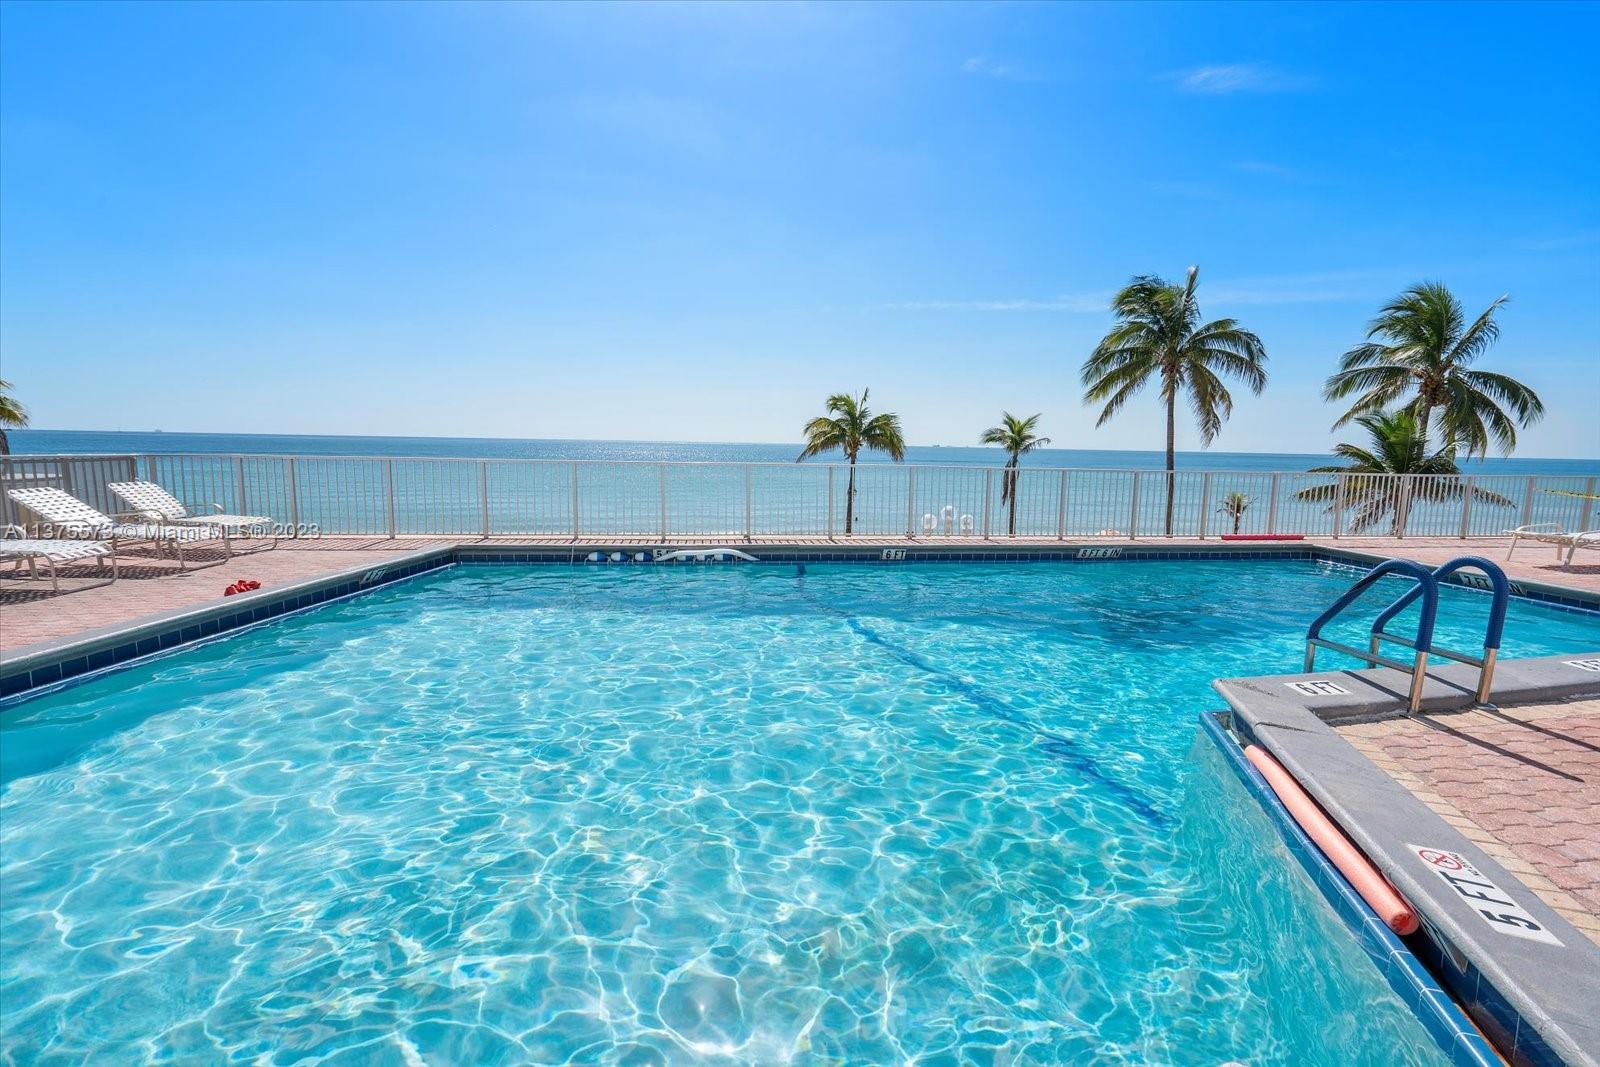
[{"left": 1214, "top": 653, "right": 1600, "bottom": 1064}]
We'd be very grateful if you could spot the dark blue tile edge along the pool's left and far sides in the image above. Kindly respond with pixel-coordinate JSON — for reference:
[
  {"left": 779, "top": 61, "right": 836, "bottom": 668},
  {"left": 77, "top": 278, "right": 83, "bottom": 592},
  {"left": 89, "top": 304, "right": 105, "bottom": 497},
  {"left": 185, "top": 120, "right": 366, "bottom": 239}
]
[{"left": 0, "top": 541, "right": 1600, "bottom": 710}]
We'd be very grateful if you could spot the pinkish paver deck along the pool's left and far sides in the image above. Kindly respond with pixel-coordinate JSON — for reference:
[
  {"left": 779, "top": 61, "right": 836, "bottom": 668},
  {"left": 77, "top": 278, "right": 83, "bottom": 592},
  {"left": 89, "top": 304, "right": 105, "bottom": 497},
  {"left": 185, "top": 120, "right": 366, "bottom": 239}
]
[{"left": 0, "top": 536, "right": 1600, "bottom": 651}]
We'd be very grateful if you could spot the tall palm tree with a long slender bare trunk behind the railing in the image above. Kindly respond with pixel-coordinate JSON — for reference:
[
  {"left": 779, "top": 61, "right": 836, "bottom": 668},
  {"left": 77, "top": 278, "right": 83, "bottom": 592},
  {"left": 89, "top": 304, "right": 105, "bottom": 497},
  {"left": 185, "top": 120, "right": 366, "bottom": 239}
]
[{"left": 1083, "top": 267, "right": 1267, "bottom": 536}]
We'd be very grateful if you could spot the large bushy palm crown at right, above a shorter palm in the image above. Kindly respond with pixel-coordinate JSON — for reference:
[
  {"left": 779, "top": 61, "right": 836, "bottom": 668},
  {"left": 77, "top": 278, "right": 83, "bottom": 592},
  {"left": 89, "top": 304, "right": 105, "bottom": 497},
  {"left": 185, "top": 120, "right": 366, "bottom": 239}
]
[{"left": 1322, "top": 282, "right": 1544, "bottom": 456}]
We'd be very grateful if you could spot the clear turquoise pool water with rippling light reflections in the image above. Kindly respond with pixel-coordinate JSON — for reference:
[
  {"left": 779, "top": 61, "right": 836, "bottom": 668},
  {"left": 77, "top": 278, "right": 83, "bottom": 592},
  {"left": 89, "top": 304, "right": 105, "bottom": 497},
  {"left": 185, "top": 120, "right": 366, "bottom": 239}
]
[{"left": 0, "top": 563, "right": 1600, "bottom": 1065}]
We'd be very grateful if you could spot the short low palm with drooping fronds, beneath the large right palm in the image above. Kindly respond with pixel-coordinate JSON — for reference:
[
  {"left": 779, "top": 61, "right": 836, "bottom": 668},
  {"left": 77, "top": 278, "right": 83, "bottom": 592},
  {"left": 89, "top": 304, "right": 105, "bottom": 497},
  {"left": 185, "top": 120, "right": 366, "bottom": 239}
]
[{"left": 1296, "top": 410, "right": 1514, "bottom": 537}]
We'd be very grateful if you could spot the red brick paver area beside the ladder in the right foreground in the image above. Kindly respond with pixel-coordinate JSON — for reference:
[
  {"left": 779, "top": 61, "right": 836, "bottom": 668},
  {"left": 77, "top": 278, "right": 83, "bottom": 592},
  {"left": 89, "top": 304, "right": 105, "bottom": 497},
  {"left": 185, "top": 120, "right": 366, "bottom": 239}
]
[{"left": 1338, "top": 701, "right": 1600, "bottom": 944}]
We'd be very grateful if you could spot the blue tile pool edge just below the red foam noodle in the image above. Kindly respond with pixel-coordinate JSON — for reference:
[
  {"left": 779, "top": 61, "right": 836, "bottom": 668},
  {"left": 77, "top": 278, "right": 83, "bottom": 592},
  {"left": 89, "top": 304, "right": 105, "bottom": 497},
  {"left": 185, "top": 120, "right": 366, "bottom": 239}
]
[{"left": 1200, "top": 712, "right": 1506, "bottom": 1067}]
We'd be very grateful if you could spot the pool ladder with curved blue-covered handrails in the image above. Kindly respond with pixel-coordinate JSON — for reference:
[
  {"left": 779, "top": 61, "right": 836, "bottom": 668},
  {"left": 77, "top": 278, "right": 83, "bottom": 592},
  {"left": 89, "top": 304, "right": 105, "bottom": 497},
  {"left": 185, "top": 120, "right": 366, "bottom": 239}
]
[{"left": 1306, "top": 555, "right": 1510, "bottom": 715}]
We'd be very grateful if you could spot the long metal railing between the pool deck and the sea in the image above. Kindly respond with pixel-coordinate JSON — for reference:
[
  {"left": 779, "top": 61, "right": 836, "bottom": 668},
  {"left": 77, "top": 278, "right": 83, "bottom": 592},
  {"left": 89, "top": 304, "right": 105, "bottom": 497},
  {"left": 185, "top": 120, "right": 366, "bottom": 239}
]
[{"left": 0, "top": 453, "right": 1597, "bottom": 539}]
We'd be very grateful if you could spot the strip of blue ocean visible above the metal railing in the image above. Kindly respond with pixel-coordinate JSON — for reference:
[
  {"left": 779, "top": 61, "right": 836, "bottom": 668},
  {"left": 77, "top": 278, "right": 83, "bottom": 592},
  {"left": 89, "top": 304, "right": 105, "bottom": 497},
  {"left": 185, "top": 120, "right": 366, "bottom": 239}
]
[{"left": 10, "top": 430, "right": 1600, "bottom": 477}]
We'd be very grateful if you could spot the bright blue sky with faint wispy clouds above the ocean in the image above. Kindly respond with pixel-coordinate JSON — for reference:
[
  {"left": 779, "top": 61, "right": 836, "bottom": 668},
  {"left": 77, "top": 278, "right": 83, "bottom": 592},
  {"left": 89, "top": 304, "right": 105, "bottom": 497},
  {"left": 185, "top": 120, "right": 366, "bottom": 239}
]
[{"left": 0, "top": 3, "right": 1600, "bottom": 456}]
